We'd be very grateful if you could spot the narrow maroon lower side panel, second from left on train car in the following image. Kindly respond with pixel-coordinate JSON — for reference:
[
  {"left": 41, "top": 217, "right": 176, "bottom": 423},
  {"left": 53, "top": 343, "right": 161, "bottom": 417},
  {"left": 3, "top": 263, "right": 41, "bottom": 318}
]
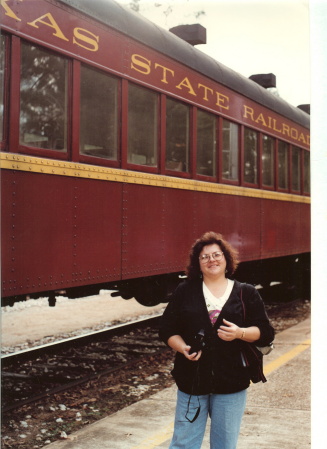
[{"left": 72, "top": 179, "right": 122, "bottom": 285}]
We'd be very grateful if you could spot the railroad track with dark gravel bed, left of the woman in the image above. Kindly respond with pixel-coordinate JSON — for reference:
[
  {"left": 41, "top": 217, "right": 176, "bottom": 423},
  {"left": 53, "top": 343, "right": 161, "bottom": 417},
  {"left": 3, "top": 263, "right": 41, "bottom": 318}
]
[{"left": 1, "top": 315, "right": 166, "bottom": 413}]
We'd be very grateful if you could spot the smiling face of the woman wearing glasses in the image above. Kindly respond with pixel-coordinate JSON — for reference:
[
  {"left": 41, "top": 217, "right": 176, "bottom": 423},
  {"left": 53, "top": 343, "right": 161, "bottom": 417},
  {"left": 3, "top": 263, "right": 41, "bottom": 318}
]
[{"left": 199, "top": 243, "right": 227, "bottom": 279}]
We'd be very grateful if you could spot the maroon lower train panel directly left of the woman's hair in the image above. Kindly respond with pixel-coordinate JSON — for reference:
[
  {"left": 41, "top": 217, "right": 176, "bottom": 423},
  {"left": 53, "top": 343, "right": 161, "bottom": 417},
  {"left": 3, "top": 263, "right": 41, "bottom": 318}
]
[{"left": 122, "top": 184, "right": 194, "bottom": 279}]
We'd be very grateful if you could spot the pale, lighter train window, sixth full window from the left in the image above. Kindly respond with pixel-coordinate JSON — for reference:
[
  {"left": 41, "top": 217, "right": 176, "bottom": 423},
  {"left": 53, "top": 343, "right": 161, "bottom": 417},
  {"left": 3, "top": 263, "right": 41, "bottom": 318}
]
[{"left": 222, "top": 120, "right": 239, "bottom": 181}]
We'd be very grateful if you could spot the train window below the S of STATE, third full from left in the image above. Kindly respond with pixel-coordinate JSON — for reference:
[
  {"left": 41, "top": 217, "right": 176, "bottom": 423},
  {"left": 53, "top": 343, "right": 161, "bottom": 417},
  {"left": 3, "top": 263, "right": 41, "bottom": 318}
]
[{"left": 127, "top": 84, "right": 159, "bottom": 167}]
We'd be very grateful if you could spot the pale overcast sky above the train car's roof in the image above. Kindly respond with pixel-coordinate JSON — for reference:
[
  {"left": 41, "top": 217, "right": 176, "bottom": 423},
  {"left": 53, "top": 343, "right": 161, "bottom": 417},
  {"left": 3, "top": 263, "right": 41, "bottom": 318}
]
[{"left": 118, "top": 0, "right": 310, "bottom": 106}]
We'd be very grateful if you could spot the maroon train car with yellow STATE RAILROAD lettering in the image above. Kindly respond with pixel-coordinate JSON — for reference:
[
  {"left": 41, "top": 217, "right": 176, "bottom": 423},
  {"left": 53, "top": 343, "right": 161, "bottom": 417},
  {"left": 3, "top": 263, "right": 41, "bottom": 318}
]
[{"left": 0, "top": 0, "right": 310, "bottom": 305}]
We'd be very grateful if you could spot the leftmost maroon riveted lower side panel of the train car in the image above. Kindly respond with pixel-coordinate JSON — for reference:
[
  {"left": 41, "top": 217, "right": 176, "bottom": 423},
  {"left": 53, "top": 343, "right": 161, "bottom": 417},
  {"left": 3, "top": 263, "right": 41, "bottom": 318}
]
[{"left": 2, "top": 170, "right": 73, "bottom": 295}]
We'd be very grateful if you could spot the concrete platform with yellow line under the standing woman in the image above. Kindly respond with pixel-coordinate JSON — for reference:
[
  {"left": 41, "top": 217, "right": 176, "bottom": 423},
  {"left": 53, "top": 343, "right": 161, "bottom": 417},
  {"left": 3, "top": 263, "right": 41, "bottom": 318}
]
[{"left": 47, "top": 319, "right": 311, "bottom": 449}]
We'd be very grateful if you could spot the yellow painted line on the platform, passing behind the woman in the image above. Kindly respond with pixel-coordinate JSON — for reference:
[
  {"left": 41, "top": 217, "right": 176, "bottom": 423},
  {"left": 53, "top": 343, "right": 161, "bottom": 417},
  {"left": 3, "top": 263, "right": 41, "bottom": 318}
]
[{"left": 131, "top": 338, "right": 311, "bottom": 449}]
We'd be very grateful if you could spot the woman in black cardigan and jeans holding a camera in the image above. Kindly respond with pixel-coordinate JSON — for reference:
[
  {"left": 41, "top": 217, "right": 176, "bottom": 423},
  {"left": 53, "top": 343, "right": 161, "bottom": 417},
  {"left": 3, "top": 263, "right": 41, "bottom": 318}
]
[{"left": 160, "top": 232, "right": 274, "bottom": 449}]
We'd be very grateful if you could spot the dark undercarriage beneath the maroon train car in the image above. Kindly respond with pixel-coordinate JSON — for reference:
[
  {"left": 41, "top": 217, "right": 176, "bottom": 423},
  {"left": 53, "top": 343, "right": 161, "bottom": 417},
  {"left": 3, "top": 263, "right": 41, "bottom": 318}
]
[{"left": 2, "top": 253, "right": 310, "bottom": 307}]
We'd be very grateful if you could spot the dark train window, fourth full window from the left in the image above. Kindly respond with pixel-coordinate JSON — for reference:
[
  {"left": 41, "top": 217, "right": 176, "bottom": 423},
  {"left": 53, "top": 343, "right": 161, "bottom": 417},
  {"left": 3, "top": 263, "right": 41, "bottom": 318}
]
[{"left": 166, "top": 98, "right": 190, "bottom": 172}]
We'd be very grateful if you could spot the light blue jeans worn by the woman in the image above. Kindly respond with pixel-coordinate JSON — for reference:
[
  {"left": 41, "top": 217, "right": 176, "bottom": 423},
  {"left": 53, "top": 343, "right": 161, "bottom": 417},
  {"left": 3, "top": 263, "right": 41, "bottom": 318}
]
[{"left": 169, "top": 390, "right": 246, "bottom": 449}]
